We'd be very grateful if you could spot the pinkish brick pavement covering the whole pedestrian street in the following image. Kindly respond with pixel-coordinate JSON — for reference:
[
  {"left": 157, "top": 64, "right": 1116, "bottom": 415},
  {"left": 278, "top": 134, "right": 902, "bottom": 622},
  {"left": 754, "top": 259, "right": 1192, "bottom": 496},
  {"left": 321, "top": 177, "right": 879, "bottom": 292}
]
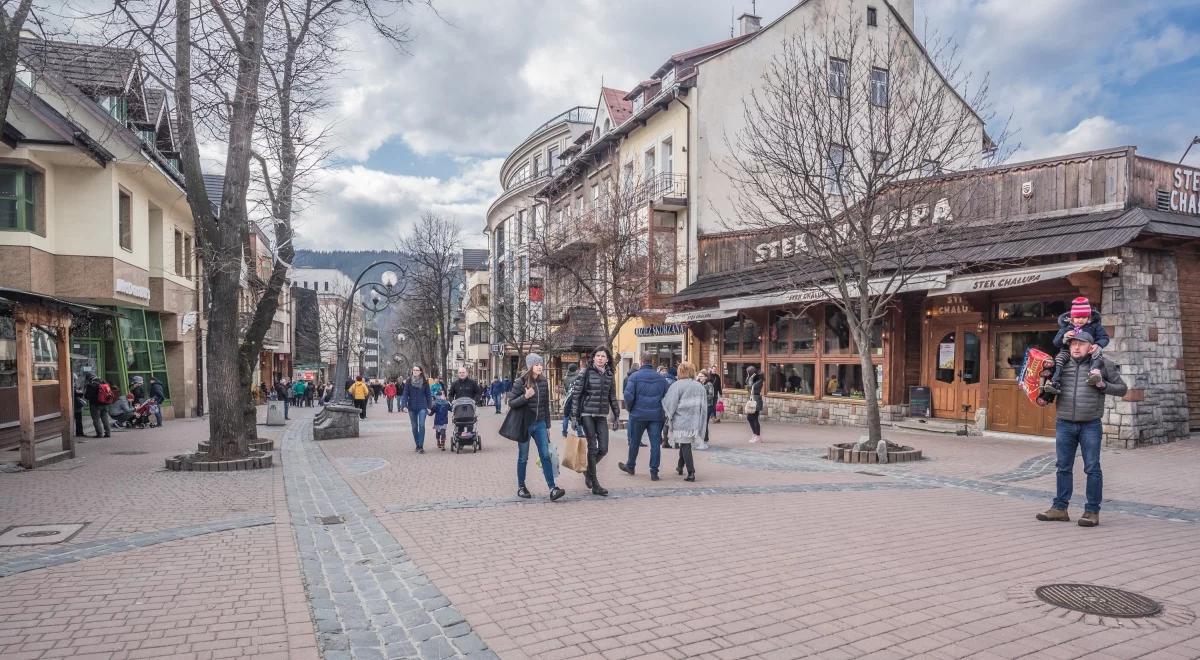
[{"left": 0, "top": 406, "right": 1200, "bottom": 660}]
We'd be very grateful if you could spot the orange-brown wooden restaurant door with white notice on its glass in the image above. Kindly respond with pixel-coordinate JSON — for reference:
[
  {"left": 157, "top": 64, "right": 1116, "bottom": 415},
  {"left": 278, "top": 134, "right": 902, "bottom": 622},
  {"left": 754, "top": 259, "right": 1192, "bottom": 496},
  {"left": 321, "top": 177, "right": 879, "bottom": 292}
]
[{"left": 929, "top": 324, "right": 983, "bottom": 420}]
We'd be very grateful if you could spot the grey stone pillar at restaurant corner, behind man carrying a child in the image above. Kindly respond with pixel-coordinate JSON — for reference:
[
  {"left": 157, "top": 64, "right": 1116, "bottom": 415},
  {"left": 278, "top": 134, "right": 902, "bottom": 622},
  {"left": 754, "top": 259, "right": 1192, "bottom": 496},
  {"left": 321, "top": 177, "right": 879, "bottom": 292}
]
[{"left": 1102, "top": 247, "right": 1188, "bottom": 449}]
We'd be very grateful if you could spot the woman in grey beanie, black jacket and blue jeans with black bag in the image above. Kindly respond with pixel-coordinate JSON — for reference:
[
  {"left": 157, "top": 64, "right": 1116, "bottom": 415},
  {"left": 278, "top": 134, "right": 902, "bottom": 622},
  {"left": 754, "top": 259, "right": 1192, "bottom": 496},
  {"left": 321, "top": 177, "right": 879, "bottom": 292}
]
[{"left": 500, "top": 353, "right": 566, "bottom": 502}]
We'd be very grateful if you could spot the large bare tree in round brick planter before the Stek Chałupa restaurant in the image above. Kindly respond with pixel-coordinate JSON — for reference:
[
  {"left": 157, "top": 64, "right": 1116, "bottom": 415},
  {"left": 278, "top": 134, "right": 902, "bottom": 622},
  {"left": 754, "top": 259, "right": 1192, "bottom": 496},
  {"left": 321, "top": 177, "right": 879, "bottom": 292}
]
[{"left": 722, "top": 24, "right": 1000, "bottom": 443}]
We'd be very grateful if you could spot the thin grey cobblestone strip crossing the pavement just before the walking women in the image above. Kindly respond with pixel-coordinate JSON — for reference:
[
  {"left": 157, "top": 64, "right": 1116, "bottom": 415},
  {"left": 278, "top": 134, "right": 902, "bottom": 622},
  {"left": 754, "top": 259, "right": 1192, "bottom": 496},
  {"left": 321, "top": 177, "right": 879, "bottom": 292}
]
[{"left": 386, "top": 481, "right": 931, "bottom": 514}]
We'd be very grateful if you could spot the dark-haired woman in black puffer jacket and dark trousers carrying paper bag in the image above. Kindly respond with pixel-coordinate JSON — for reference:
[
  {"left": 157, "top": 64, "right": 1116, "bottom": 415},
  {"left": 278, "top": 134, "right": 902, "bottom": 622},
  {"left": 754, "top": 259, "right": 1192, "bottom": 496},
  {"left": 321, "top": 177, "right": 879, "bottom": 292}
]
[{"left": 570, "top": 346, "right": 620, "bottom": 497}]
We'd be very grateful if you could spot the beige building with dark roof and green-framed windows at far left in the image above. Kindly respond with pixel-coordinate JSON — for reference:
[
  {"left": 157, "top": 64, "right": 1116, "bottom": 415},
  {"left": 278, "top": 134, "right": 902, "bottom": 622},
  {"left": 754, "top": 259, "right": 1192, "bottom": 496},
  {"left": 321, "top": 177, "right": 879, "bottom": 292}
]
[{"left": 0, "top": 38, "right": 200, "bottom": 434}]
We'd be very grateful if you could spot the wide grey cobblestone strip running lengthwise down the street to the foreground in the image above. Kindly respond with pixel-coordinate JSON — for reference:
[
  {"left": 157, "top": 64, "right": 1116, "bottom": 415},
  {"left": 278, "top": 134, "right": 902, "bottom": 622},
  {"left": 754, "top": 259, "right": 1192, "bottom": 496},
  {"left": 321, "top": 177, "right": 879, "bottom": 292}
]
[{"left": 282, "top": 420, "right": 496, "bottom": 660}]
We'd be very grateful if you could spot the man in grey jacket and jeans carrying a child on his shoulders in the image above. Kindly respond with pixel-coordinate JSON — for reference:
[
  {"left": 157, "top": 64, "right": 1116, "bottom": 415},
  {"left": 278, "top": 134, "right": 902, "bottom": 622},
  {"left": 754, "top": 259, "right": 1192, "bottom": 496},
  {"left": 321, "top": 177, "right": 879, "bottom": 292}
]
[{"left": 1037, "top": 332, "right": 1127, "bottom": 527}]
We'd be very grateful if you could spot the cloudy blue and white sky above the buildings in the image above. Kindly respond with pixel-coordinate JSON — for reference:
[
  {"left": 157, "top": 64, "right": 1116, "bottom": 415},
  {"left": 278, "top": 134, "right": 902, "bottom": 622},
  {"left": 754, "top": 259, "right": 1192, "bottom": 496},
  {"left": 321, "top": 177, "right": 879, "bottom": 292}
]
[{"left": 180, "top": 0, "right": 1200, "bottom": 250}]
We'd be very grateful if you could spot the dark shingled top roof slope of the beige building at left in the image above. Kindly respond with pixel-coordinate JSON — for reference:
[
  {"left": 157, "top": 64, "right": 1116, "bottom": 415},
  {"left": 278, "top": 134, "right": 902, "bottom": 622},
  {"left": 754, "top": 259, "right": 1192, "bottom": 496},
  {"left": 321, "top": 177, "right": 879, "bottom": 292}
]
[{"left": 20, "top": 38, "right": 138, "bottom": 91}]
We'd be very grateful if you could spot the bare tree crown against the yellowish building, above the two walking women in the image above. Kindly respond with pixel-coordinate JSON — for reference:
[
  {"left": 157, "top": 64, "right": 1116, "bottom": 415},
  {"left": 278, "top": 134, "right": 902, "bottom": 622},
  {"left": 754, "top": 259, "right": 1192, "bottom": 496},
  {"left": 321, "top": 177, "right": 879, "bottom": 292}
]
[{"left": 537, "top": 167, "right": 678, "bottom": 346}]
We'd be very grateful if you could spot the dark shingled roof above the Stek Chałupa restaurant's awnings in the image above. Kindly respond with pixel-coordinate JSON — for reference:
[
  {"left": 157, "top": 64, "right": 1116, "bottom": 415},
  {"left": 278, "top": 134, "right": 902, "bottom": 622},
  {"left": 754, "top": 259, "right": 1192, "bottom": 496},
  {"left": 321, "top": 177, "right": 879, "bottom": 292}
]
[{"left": 671, "top": 209, "right": 1147, "bottom": 305}]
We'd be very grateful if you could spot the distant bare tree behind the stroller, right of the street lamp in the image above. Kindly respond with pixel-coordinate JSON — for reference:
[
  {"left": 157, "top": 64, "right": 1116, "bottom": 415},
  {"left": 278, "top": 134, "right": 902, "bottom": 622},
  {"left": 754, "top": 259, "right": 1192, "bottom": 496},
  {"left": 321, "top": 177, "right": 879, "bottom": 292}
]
[{"left": 400, "top": 212, "right": 463, "bottom": 377}]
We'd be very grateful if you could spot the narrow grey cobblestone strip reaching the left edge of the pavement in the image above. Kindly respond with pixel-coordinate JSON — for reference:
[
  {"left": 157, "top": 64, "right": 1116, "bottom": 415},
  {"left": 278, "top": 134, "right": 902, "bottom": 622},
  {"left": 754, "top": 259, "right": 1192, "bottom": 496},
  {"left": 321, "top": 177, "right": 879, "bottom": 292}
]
[{"left": 0, "top": 515, "right": 275, "bottom": 577}]
